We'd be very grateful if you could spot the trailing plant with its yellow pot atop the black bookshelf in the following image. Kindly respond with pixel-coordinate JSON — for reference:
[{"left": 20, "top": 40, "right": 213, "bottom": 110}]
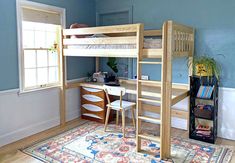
[{"left": 190, "top": 56, "right": 221, "bottom": 80}]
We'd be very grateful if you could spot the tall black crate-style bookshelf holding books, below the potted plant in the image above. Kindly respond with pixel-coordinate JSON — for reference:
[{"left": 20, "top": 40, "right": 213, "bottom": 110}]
[{"left": 189, "top": 76, "right": 218, "bottom": 144}]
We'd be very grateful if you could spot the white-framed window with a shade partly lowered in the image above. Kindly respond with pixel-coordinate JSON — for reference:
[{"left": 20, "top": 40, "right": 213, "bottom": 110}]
[{"left": 18, "top": 1, "right": 64, "bottom": 91}]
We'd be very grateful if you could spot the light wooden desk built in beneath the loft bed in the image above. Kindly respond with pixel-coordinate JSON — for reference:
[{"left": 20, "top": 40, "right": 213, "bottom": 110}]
[{"left": 66, "top": 80, "right": 189, "bottom": 123}]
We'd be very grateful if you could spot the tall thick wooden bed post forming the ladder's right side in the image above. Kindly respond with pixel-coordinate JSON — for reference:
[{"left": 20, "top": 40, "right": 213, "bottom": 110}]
[{"left": 160, "top": 21, "right": 173, "bottom": 159}]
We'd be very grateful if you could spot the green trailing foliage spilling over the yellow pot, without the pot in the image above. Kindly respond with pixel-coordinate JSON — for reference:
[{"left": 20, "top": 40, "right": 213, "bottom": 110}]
[{"left": 189, "top": 55, "right": 221, "bottom": 79}]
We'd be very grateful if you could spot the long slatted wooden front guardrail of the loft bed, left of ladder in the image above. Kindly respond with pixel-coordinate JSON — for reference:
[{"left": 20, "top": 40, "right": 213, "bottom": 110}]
[{"left": 62, "top": 24, "right": 140, "bottom": 58}]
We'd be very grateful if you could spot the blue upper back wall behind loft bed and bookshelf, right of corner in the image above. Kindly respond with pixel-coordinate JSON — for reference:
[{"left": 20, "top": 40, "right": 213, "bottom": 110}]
[{"left": 96, "top": 0, "right": 235, "bottom": 87}]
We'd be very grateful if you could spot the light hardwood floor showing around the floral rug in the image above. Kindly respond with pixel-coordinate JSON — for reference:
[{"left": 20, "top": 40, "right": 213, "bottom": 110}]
[{"left": 0, "top": 119, "right": 235, "bottom": 163}]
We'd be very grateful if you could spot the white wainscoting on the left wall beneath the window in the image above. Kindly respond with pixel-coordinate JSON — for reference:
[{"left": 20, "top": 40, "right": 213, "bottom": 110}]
[{"left": 0, "top": 85, "right": 80, "bottom": 147}]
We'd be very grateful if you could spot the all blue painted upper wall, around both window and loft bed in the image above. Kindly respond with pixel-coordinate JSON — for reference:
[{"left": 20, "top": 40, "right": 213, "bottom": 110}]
[{"left": 0, "top": 0, "right": 235, "bottom": 90}]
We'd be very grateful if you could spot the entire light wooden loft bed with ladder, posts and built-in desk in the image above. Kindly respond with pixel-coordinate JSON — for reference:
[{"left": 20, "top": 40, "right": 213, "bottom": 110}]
[{"left": 60, "top": 21, "right": 194, "bottom": 158}]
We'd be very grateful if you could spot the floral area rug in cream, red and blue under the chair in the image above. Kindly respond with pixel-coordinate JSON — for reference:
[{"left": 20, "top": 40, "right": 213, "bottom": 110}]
[{"left": 22, "top": 122, "right": 233, "bottom": 163}]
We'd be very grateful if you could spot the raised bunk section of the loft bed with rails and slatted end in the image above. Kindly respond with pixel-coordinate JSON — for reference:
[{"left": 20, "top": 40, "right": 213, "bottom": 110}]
[{"left": 63, "top": 23, "right": 194, "bottom": 58}]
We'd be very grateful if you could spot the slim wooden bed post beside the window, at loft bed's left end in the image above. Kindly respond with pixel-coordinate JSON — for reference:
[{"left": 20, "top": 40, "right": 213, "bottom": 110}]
[{"left": 60, "top": 30, "right": 66, "bottom": 126}]
